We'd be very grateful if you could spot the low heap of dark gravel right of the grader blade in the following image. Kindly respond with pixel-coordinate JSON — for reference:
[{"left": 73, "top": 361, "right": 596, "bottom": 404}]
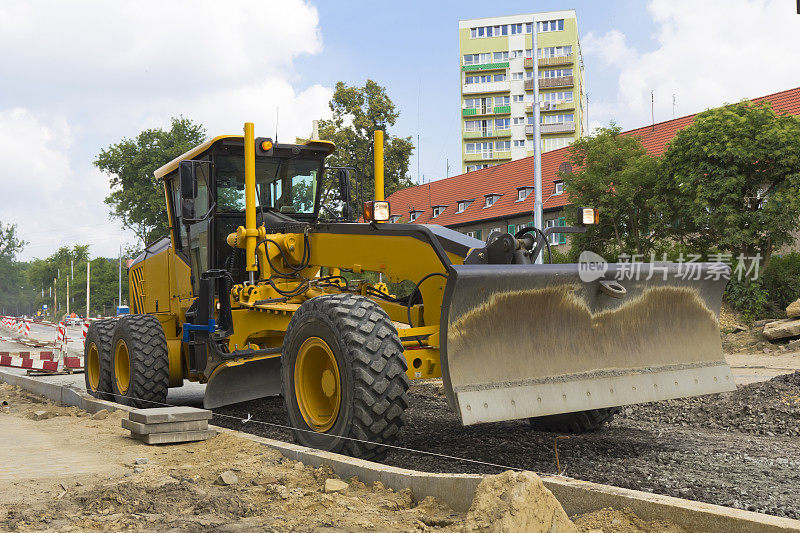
[{"left": 622, "top": 371, "right": 800, "bottom": 436}]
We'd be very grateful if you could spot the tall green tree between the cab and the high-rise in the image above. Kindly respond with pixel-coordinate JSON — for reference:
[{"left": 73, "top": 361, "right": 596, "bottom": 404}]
[{"left": 298, "top": 80, "right": 414, "bottom": 213}]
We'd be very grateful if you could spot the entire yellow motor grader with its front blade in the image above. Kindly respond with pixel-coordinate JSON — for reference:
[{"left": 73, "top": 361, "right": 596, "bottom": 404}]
[{"left": 85, "top": 123, "right": 734, "bottom": 458}]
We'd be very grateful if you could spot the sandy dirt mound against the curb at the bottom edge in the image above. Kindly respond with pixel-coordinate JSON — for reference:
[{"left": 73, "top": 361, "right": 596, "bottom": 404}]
[{"left": 465, "top": 470, "right": 576, "bottom": 533}]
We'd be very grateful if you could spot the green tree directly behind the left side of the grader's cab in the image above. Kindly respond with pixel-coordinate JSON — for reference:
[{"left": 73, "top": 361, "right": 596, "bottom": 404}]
[{"left": 94, "top": 117, "right": 206, "bottom": 244}]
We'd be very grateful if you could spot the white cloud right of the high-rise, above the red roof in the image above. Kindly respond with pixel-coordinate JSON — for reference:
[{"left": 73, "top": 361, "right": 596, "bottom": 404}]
[{"left": 584, "top": 0, "right": 800, "bottom": 129}]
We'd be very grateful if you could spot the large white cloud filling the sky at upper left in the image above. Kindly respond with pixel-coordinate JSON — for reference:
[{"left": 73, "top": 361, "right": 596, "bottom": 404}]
[{"left": 0, "top": 0, "right": 332, "bottom": 258}]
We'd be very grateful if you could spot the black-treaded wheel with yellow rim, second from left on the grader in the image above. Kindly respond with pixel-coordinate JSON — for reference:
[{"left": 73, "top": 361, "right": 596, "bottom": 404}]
[{"left": 111, "top": 315, "right": 169, "bottom": 409}]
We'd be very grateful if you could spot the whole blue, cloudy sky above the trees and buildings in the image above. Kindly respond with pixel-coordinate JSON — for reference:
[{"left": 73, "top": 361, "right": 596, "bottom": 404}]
[{"left": 0, "top": 0, "right": 800, "bottom": 260}]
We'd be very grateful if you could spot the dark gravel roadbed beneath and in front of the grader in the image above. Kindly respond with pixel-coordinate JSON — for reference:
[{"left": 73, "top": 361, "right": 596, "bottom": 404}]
[{"left": 214, "top": 372, "right": 800, "bottom": 519}]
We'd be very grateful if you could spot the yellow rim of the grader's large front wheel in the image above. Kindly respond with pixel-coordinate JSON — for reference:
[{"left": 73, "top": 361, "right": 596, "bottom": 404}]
[{"left": 294, "top": 337, "right": 342, "bottom": 433}]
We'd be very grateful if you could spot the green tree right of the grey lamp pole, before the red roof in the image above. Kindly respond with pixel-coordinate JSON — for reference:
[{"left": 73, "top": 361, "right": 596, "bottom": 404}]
[{"left": 562, "top": 123, "right": 665, "bottom": 258}]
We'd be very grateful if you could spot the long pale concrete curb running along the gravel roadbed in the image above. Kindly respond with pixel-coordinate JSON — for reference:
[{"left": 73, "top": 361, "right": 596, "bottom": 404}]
[{"left": 0, "top": 370, "right": 800, "bottom": 533}]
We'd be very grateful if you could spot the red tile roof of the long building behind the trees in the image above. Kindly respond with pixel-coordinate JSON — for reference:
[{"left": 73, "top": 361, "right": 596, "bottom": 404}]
[{"left": 387, "top": 87, "right": 800, "bottom": 226}]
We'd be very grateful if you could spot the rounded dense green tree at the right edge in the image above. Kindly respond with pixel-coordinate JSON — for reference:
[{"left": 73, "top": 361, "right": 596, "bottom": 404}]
[{"left": 659, "top": 102, "right": 800, "bottom": 267}]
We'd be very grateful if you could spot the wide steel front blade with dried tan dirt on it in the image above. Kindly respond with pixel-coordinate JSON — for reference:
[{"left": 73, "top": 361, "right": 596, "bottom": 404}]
[{"left": 440, "top": 264, "right": 735, "bottom": 425}]
